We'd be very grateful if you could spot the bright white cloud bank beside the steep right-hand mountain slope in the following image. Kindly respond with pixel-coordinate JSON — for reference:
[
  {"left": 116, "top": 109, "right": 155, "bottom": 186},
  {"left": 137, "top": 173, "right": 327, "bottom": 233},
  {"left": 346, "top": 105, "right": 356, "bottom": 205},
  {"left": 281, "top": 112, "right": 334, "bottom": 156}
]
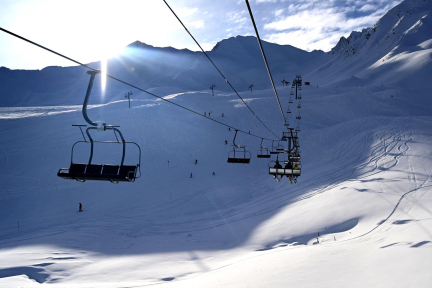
[{"left": 264, "top": 0, "right": 400, "bottom": 51}]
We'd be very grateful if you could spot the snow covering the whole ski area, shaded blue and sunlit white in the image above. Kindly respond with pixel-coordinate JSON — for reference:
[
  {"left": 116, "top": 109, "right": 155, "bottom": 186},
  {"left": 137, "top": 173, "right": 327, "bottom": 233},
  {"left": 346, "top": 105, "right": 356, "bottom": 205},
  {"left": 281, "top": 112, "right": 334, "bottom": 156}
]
[{"left": 0, "top": 0, "right": 432, "bottom": 288}]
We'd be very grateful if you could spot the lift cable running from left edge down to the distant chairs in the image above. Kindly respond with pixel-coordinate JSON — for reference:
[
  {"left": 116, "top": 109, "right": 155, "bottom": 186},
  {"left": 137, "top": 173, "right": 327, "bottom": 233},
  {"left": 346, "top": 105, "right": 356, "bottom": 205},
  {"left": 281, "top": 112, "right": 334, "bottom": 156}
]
[{"left": 0, "top": 27, "right": 277, "bottom": 140}]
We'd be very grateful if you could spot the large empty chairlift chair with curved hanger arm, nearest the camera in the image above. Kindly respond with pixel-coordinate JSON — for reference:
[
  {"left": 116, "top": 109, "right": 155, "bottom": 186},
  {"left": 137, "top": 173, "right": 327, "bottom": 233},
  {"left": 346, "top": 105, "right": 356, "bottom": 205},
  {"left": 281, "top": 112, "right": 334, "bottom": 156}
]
[{"left": 57, "top": 71, "right": 141, "bottom": 184}]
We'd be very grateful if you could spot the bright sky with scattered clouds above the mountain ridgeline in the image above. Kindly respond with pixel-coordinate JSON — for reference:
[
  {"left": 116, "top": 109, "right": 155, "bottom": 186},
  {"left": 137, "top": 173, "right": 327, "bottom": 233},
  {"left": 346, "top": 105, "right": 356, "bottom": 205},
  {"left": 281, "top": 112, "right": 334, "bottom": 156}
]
[{"left": 0, "top": 0, "right": 401, "bottom": 69}]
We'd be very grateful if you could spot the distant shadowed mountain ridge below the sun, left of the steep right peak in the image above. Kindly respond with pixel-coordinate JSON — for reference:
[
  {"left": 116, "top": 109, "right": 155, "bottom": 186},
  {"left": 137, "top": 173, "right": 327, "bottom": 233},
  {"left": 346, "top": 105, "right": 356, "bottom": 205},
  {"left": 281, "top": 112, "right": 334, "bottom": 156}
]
[{"left": 0, "top": 36, "right": 324, "bottom": 107}]
